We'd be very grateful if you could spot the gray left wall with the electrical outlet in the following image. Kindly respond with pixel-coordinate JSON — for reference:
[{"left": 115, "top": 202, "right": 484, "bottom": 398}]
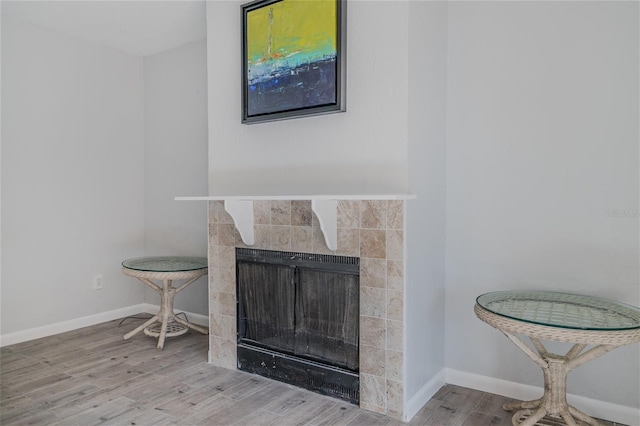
[{"left": 1, "top": 15, "right": 144, "bottom": 335}]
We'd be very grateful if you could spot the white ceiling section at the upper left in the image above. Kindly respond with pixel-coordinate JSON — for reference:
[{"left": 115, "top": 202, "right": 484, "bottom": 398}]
[{"left": 1, "top": 0, "right": 206, "bottom": 56}]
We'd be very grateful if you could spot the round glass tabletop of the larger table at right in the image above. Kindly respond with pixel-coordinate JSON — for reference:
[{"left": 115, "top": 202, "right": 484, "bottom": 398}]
[{"left": 476, "top": 290, "right": 640, "bottom": 331}]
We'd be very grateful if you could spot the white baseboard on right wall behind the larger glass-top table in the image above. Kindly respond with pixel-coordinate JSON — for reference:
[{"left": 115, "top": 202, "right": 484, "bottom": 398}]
[{"left": 444, "top": 368, "right": 640, "bottom": 426}]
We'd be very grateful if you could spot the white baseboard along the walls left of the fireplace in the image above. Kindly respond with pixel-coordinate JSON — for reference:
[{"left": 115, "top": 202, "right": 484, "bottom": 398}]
[{"left": 0, "top": 303, "right": 209, "bottom": 347}]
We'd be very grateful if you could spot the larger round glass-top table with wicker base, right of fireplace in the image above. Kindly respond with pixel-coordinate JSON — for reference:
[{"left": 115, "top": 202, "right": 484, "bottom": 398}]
[{"left": 474, "top": 291, "right": 640, "bottom": 426}]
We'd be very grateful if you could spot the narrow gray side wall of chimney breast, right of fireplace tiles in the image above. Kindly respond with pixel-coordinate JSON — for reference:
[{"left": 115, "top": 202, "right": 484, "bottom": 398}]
[{"left": 405, "top": 2, "right": 447, "bottom": 402}]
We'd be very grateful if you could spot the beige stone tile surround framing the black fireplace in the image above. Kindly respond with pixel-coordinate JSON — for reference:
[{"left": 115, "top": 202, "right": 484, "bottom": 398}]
[{"left": 209, "top": 200, "right": 404, "bottom": 419}]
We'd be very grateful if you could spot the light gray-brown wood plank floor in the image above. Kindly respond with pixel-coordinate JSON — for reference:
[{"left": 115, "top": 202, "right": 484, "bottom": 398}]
[{"left": 0, "top": 319, "right": 614, "bottom": 426}]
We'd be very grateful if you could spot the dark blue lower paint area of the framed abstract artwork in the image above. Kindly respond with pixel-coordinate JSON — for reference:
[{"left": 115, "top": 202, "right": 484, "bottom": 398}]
[{"left": 247, "top": 56, "right": 337, "bottom": 116}]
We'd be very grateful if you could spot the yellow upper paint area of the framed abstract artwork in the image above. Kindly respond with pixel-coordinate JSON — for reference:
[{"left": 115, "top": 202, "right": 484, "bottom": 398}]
[{"left": 247, "top": 0, "right": 337, "bottom": 61}]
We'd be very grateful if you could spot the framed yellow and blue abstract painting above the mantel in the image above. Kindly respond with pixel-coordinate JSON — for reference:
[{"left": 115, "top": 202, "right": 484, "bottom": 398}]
[{"left": 242, "top": 0, "right": 346, "bottom": 124}]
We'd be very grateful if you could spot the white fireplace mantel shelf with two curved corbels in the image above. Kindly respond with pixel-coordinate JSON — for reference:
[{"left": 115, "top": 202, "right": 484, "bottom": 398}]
[{"left": 175, "top": 194, "right": 416, "bottom": 250}]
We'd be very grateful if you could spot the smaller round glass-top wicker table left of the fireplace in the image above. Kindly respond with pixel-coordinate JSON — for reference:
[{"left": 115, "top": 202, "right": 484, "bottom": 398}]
[{"left": 122, "top": 256, "right": 208, "bottom": 349}]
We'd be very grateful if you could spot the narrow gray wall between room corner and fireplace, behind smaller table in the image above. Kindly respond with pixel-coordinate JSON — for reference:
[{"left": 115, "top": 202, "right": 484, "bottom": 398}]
[{"left": 143, "top": 40, "right": 208, "bottom": 316}]
